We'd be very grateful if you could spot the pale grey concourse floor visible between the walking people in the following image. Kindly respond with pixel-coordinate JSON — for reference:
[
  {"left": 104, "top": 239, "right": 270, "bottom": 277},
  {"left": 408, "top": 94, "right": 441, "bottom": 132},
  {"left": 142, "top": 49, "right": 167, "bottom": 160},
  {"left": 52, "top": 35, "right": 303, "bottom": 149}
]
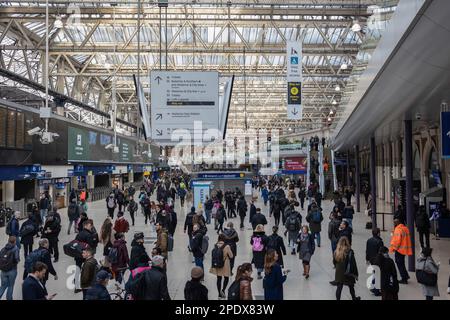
[{"left": 0, "top": 190, "right": 450, "bottom": 300}]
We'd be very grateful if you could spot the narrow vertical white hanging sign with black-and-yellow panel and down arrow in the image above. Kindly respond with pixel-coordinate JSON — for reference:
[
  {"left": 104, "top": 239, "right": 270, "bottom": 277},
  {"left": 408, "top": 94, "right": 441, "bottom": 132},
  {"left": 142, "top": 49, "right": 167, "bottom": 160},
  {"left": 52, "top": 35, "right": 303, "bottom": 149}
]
[{"left": 286, "top": 41, "right": 303, "bottom": 120}]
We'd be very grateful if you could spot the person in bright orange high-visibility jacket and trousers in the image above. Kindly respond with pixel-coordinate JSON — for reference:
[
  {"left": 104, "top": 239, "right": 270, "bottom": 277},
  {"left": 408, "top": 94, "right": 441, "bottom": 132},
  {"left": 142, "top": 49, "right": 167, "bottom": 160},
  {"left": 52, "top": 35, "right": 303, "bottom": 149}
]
[{"left": 389, "top": 219, "right": 413, "bottom": 284}]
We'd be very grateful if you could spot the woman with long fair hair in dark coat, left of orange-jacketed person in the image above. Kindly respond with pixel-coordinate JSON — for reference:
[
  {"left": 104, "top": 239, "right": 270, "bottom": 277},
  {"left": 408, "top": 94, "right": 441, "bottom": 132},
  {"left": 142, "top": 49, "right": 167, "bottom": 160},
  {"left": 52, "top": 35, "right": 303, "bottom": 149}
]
[{"left": 334, "top": 237, "right": 361, "bottom": 300}]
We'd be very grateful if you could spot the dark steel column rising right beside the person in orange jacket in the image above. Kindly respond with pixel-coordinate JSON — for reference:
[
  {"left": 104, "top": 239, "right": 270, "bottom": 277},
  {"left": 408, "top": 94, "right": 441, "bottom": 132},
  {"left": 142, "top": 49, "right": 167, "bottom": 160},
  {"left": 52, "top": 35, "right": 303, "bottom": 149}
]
[{"left": 404, "top": 120, "right": 416, "bottom": 272}]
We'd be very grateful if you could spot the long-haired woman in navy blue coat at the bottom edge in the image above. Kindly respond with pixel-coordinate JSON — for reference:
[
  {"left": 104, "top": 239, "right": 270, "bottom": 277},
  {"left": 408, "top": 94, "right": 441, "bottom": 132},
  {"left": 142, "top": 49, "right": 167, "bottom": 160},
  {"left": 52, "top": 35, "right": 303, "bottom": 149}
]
[{"left": 263, "top": 249, "right": 289, "bottom": 300}]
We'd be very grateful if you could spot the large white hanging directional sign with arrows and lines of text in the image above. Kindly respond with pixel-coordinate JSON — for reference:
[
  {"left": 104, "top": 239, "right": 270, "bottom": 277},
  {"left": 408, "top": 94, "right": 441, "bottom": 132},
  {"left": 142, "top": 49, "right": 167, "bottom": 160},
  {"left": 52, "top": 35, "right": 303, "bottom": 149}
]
[{"left": 150, "top": 71, "right": 219, "bottom": 141}]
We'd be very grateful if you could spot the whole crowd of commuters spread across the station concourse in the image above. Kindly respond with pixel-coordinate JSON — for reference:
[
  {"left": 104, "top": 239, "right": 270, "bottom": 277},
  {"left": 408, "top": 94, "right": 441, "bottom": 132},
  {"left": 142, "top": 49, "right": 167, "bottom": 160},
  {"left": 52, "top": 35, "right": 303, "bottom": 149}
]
[{"left": 0, "top": 172, "right": 448, "bottom": 300}]
